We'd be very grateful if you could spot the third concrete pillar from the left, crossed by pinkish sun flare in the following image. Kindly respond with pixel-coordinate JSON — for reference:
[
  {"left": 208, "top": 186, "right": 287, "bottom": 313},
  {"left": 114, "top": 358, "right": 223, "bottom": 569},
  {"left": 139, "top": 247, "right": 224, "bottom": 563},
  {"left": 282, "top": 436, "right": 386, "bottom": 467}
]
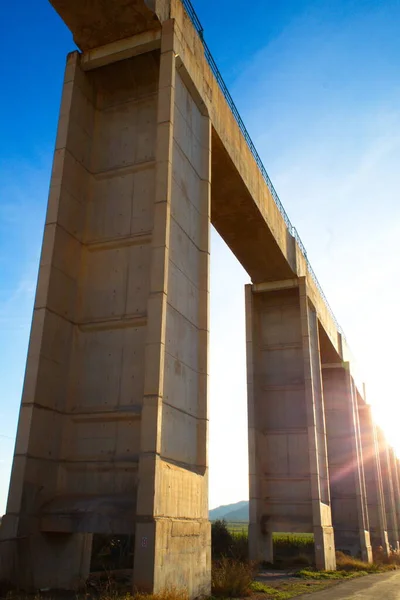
[{"left": 322, "top": 363, "right": 372, "bottom": 562}]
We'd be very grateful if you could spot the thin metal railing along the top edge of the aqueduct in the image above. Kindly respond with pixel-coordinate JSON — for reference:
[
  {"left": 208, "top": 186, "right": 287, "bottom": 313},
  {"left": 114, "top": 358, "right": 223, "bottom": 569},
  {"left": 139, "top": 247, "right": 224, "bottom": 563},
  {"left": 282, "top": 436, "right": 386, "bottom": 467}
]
[{"left": 182, "top": 0, "right": 345, "bottom": 337}]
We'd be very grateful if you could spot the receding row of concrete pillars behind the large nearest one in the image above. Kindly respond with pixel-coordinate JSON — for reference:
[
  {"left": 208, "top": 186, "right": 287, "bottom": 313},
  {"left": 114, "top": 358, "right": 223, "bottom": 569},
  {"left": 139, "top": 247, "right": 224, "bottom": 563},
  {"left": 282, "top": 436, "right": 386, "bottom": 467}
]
[{"left": 246, "top": 277, "right": 400, "bottom": 569}]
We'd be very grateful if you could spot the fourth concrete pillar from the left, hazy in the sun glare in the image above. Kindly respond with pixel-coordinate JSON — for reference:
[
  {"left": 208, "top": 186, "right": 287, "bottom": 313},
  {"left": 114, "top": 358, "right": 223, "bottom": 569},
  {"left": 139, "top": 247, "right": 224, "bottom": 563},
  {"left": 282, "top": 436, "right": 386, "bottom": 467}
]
[{"left": 358, "top": 397, "right": 389, "bottom": 555}]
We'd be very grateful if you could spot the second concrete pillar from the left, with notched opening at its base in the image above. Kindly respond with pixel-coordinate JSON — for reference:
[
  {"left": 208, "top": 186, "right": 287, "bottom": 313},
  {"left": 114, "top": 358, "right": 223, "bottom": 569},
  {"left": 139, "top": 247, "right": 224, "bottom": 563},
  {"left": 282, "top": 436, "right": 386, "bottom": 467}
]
[{"left": 246, "top": 278, "right": 336, "bottom": 569}]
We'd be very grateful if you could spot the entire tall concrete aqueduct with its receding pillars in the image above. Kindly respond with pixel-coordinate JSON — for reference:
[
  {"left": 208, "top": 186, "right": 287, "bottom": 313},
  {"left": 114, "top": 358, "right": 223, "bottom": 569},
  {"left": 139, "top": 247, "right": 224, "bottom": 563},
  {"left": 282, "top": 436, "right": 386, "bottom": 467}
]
[{"left": 0, "top": 0, "right": 400, "bottom": 597}]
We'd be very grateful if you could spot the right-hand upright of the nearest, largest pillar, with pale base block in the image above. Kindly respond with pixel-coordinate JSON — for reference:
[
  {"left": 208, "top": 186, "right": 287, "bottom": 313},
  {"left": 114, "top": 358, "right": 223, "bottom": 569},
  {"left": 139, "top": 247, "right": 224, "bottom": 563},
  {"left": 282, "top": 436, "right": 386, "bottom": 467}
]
[{"left": 134, "top": 21, "right": 211, "bottom": 597}]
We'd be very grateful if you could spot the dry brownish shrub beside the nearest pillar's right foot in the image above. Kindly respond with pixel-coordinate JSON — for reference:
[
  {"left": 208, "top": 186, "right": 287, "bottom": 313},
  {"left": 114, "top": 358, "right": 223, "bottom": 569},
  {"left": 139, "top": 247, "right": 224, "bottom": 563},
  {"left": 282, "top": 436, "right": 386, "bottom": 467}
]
[{"left": 211, "top": 557, "right": 254, "bottom": 598}]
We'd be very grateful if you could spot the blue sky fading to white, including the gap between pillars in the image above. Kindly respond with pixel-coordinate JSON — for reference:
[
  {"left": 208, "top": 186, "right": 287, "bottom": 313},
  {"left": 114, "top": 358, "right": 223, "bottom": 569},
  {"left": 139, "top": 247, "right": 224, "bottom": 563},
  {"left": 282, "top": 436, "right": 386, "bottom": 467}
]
[{"left": 0, "top": 0, "right": 400, "bottom": 514}]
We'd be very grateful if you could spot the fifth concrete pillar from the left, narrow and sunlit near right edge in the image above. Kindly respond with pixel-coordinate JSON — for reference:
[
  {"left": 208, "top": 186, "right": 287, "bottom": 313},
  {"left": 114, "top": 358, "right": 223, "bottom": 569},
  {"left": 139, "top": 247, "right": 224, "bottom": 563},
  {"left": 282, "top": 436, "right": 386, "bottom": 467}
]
[{"left": 377, "top": 427, "right": 399, "bottom": 550}]
